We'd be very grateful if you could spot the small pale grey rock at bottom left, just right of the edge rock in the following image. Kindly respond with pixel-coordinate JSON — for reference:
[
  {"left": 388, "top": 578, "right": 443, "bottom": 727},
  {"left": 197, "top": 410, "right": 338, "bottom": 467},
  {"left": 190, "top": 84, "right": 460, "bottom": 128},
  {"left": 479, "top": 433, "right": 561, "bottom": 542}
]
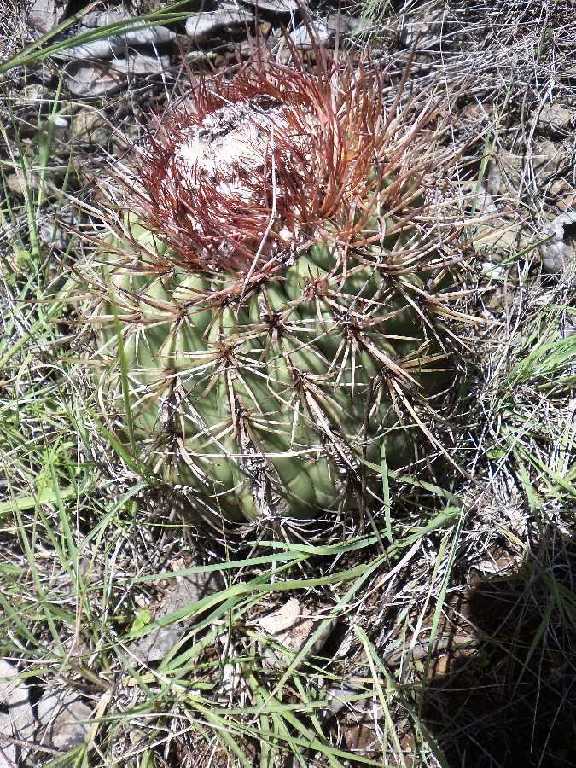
[{"left": 38, "top": 690, "right": 92, "bottom": 751}]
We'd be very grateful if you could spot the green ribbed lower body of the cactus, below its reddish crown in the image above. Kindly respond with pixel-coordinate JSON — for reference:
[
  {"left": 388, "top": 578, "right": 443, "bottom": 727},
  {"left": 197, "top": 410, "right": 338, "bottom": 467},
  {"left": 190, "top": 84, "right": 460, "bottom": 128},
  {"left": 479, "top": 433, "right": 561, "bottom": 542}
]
[{"left": 100, "top": 228, "right": 444, "bottom": 519}]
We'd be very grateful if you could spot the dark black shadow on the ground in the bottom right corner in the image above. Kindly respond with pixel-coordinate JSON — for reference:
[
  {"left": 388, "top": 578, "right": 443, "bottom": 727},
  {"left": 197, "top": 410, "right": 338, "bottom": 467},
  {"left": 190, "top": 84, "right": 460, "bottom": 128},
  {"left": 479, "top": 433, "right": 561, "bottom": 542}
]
[{"left": 423, "top": 532, "right": 576, "bottom": 768}]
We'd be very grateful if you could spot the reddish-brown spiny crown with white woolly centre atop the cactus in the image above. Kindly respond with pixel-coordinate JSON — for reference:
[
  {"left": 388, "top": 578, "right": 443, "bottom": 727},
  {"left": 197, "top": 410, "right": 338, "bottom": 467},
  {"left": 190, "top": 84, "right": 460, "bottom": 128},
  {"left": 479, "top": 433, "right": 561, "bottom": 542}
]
[{"left": 130, "top": 57, "right": 428, "bottom": 276}]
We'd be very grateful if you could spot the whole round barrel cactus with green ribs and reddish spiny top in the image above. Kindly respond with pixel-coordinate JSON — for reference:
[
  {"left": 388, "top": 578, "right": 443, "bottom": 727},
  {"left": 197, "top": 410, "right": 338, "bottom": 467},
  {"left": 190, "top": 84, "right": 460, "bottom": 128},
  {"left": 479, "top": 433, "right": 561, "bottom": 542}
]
[{"left": 89, "top": 61, "right": 470, "bottom": 520}]
